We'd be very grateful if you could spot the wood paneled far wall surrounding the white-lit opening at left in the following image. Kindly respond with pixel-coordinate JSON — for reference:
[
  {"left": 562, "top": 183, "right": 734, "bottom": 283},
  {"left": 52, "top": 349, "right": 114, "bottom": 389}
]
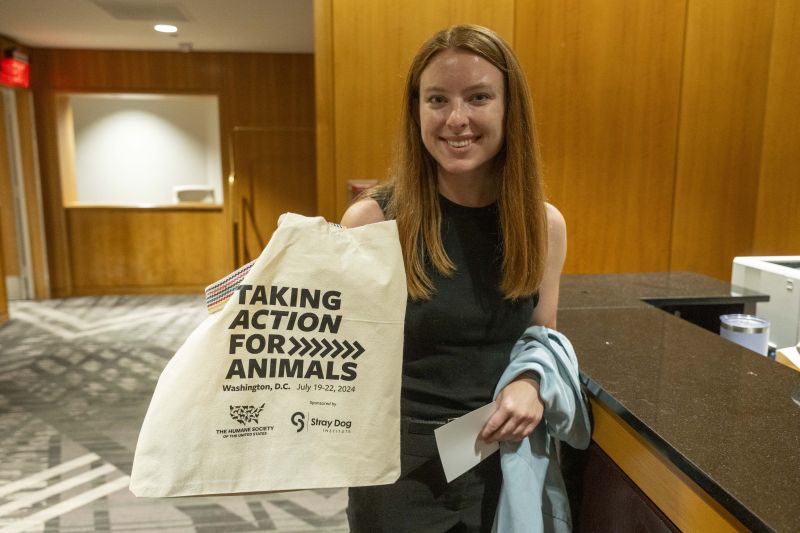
[{"left": 31, "top": 49, "right": 316, "bottom": 296}]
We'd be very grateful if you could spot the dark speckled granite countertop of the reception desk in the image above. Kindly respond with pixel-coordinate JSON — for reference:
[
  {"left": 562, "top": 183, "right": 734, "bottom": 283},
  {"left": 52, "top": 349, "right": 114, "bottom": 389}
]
[{"left": 558, "top": 273, "right": 800, "bottom": 532}]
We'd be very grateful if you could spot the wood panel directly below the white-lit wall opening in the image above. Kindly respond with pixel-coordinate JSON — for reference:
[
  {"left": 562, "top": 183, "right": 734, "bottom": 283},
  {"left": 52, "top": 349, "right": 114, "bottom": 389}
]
[{"left": 67, "top": 207, "right": 230, "bottom": 294}]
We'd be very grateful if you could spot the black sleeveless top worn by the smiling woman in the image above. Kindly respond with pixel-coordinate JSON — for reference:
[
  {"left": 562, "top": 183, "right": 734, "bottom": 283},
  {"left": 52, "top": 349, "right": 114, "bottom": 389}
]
[{"left": 379, "top": 195, "right": 538, "bottom": 420}]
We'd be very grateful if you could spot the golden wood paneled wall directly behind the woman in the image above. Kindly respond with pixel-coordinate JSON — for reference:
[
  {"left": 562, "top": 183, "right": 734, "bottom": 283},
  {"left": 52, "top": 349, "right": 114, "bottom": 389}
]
[{"left": 316, "top": 0, "right": 800, "bottom": 280}]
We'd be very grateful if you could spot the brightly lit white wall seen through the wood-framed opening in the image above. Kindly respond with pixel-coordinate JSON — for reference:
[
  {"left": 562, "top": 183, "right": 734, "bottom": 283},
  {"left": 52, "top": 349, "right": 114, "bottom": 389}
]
[{"left": 69, "top": 94, "right": 222, "bottom": 204}]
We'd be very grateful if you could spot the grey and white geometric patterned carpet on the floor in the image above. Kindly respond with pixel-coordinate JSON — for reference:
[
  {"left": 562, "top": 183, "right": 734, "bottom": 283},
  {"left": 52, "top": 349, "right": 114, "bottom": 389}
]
[{"left": 0, "top": 296, "right": 347, "bottom": 533}]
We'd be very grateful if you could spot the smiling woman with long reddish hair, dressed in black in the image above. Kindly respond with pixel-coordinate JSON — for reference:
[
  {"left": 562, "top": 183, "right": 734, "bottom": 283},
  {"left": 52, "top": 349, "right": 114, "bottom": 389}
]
[{"left": 342, "top": 25, "right": 566, "bottom": 532}]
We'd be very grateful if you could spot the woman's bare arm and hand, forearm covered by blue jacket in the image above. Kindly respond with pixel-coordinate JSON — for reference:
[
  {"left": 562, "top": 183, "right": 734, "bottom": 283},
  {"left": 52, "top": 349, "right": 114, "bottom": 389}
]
[{"left": 481, "top": 204, "right": 567, "bottom": 442}]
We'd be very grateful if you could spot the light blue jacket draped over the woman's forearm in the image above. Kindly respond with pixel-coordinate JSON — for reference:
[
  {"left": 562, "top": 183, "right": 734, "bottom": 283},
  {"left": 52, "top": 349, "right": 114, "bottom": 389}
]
[{"left": 493, "top": 326, "right": 591, "bottom": 533}]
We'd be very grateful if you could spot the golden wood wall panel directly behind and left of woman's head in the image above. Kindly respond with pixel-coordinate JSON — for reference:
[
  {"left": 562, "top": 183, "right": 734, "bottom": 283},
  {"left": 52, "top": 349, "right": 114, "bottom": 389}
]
[{"left": 330, "top": 0, "right": 514, "bottom": 218}]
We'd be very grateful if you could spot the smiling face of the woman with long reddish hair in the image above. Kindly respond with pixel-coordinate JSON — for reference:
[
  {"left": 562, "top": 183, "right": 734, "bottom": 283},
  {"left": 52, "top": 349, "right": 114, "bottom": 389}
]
[{"left": 419, "top": 48, "right": 505, "bottom": 186}]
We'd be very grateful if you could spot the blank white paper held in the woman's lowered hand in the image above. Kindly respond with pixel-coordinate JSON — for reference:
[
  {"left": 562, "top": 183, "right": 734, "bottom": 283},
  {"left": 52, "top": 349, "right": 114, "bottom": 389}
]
[{"left": 434, "top": 402, "right": 500, "bottom": 483}]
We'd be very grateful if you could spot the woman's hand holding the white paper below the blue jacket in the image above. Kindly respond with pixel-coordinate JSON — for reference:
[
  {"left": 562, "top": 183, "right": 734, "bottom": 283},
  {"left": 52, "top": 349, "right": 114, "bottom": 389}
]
[{"left": 480, "top": 374, "right": 544, "bottom": 442}]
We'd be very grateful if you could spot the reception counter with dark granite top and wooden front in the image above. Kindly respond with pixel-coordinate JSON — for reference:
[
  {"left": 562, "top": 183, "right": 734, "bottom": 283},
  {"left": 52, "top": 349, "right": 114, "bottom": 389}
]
[{"left": 558, "top": 273, "right": 800, "bottom": 532}]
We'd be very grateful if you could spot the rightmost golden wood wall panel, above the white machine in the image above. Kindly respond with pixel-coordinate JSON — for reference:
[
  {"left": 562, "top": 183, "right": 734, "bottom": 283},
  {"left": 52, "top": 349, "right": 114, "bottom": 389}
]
[{"left": 753, "top": 0, "right": 800, "bottom": 255}]
